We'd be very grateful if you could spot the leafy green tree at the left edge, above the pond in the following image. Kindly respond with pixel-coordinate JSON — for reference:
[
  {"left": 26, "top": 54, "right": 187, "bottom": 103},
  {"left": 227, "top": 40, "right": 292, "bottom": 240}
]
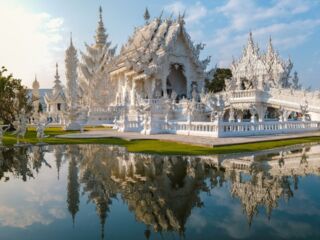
[{"left": 0, "top": 67, "right": 32, "bottom": 124}]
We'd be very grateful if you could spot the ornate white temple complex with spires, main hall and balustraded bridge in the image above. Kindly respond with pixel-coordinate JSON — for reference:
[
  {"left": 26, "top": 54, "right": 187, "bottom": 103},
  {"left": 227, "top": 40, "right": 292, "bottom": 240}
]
[{"left": 33, "top": 8, "right": 320, "bottom": 137}]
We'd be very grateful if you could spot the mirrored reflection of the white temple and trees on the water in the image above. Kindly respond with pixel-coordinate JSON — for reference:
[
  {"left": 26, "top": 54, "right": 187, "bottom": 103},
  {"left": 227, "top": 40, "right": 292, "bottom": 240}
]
[{"left": 0, "top": 145, "right": 320, "bottom": 239}]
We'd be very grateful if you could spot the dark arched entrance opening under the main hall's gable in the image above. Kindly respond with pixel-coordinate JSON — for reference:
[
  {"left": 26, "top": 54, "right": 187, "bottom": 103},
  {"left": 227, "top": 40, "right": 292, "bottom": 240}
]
[{"left": 167, "top": 64, "right": 187, "bottom": 99}]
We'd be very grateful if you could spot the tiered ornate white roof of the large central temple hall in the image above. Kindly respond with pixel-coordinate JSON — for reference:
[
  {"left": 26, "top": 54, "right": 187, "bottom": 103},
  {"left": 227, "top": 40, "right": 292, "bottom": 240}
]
[{"left": 110, "top": 16, "right": 209, "bottom": 75}]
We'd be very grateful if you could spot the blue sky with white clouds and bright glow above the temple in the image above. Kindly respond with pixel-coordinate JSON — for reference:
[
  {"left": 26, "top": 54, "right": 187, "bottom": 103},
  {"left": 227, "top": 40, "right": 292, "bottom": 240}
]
[{"left": 0, "top": 0, "right": 320, "bottom": 89}]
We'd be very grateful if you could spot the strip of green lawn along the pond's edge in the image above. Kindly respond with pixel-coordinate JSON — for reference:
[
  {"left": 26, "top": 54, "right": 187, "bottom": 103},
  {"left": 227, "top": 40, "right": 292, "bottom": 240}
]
[{"left": 3, "top": 128, "right": 320, "bottom": 155}]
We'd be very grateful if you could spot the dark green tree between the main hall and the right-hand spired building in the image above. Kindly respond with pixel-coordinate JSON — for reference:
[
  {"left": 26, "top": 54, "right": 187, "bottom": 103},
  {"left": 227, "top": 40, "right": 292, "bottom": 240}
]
[{"left": 206, "top": 68, "right": 232, "bottom": 93}]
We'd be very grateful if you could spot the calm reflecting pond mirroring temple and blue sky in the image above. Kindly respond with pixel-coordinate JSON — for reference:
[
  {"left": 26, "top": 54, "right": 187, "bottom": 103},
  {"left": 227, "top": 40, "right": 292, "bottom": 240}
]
[{"left": 0, "top": 145, "right": 320, "bottom": 240}]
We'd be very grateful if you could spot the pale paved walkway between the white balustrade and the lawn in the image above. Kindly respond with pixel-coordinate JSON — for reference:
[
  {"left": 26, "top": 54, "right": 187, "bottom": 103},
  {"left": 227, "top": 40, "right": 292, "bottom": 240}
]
[{"left": 57, "top": 130, "right": 320, "bottom": 147}]
